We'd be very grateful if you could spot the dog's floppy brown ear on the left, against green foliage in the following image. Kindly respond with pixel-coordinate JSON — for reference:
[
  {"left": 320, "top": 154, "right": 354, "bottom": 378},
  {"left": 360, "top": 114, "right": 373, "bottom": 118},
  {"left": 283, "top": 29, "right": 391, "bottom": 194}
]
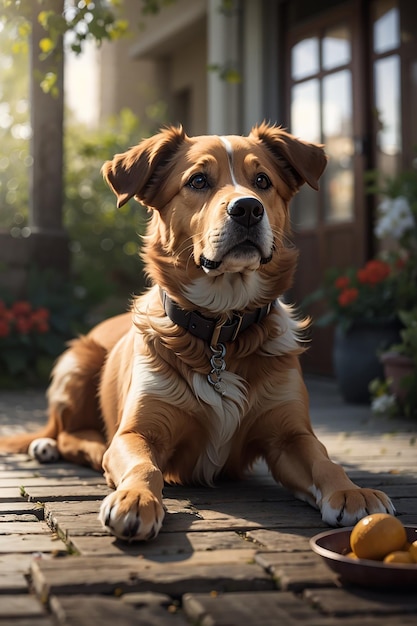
[{"left": 101, "top": 126, "right": 186, "bottom": 208}]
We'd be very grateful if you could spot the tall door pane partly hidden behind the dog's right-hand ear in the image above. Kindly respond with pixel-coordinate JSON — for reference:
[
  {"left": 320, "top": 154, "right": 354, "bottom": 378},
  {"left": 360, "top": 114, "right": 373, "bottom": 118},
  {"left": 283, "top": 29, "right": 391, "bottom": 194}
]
[{"left": 291, "top": 78, "right": 321, "bottom": 231}]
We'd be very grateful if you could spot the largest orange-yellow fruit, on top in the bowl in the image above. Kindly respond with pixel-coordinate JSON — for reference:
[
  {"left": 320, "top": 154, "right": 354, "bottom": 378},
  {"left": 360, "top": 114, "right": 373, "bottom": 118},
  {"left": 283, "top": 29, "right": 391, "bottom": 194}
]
[{"left": 350, "top": 513, "right": 407, "bottom": 561}]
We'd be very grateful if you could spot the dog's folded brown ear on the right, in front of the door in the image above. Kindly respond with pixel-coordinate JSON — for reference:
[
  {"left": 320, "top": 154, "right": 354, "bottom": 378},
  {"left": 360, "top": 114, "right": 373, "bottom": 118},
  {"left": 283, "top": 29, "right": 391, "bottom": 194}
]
[{"left": 250, "top": 123, "right": 327, "bottom": 190}]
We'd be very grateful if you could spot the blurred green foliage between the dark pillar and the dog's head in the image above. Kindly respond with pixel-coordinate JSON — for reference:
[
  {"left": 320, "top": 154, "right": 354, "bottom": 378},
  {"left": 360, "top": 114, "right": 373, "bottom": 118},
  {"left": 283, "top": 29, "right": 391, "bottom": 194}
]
[{"left": 64, "top": 110, "right": 151, "bottom": 312}]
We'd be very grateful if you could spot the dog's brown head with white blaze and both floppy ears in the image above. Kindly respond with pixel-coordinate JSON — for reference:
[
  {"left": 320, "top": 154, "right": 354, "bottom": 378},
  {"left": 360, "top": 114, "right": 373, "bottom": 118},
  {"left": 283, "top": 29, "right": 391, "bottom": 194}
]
[{"left": 103, "top": 124, "right": 326, "bottom": 312}]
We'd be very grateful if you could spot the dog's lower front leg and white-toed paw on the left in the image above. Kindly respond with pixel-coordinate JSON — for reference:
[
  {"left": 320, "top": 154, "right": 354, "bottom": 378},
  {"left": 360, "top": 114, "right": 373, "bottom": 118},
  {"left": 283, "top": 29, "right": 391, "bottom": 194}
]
[{"left": 99, "top": 432, "right": 164, "bottom": 541}]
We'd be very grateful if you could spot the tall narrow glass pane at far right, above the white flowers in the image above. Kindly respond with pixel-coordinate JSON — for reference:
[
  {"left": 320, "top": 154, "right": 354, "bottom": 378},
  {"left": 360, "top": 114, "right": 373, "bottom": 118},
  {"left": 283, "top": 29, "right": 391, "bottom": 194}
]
[{"left": 375, "top": 54, "right": 402, "bottom": 174}]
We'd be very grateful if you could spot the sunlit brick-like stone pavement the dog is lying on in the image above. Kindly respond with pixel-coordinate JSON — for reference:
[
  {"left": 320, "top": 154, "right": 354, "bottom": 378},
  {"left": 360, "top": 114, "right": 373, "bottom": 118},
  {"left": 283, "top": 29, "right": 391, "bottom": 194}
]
[{"left": 0, "top": 379, "right": 417, "bottom": 626}]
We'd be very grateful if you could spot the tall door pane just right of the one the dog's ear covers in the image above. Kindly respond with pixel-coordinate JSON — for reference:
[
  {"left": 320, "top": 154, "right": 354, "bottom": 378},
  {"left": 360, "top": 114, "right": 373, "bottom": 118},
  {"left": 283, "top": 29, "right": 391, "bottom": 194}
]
[{"left": 323, "top": 70, "right": 354, "bottom": 222}]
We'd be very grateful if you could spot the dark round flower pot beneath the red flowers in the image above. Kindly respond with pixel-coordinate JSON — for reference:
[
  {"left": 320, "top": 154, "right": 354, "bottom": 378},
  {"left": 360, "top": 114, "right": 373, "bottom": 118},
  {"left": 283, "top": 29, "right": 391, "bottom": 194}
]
[{"left": 333, "top": 322, "right": 400, "bottom": 404}]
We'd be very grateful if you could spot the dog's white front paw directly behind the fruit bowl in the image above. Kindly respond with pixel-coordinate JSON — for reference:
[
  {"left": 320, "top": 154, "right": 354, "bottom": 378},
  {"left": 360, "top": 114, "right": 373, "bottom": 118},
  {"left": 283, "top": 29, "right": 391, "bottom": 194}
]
[{"left": 320, "top": 488, "right": 396, "bottom": 526}]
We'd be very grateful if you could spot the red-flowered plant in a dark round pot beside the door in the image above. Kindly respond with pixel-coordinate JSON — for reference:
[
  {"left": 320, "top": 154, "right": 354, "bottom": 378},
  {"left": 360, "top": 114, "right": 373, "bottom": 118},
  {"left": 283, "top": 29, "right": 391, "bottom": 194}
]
[{"left": 309, "top": 255, "right": 408, "bottom": 403}]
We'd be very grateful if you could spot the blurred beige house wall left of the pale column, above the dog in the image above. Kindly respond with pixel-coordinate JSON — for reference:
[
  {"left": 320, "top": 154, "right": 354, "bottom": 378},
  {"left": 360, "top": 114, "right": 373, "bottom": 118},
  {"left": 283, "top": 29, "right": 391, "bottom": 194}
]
[{"left": 99, "top": 0, "right": 207, "bottom": 134}]
